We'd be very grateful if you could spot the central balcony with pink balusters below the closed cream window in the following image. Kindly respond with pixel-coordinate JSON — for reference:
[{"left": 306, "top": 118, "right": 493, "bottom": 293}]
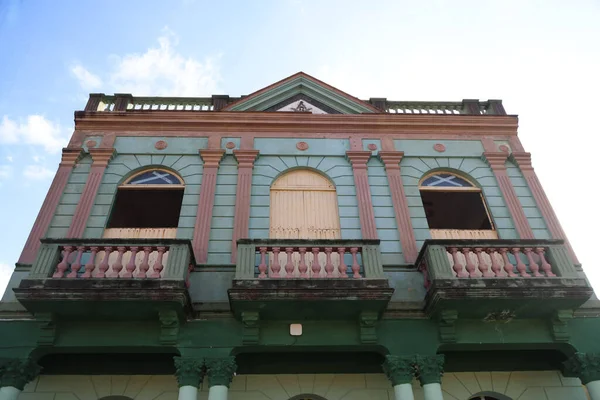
[{"left": 229, "top": 239, "right": 394, "bottom": 319}]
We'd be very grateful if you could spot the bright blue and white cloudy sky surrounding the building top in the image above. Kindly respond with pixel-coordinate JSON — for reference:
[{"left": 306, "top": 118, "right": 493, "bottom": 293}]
[{"left": 0, "top": 0, "right": 600, "bottom": 289}]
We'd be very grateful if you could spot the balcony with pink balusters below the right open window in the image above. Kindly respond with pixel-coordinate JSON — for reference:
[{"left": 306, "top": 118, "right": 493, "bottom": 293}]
[{"left": 416, "top": 239, "right": 593, "bottom": 318}]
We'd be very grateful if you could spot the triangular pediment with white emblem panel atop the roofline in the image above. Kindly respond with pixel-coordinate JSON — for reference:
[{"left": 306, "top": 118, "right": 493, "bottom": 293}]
[{"left": 223, "top": 72, "right": 380, "bottom": 114}]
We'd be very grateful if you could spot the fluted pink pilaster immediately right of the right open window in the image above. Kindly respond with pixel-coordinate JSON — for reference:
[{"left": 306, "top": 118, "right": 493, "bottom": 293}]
[{"left": 483, "top": 152, "right": 534, "bottom": 239}]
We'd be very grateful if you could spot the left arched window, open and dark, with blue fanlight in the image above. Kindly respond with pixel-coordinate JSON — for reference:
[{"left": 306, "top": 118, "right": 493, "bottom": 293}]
[{"left": 104, "top": 168, "right": 184, "bottom": 238}]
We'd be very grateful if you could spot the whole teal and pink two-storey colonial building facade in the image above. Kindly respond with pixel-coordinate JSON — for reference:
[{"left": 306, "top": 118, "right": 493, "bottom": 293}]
[{"left": 0, "top": 73, "right": 600, "bottom": 400}]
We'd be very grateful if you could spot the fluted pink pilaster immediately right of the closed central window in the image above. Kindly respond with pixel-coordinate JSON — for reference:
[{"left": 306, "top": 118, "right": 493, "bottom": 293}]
[{"left": 346, "top": 151, "right": 377, "bottom": 239}]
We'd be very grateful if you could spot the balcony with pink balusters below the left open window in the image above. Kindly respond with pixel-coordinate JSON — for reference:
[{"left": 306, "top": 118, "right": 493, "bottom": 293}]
[{"left": 13, "top": 239, "right": 195, "bottom": 318}]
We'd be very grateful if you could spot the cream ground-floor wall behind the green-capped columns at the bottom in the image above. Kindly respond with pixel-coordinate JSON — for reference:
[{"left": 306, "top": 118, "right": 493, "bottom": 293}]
[{"left": 19, "top": 371, "right": 586, "bottom": 400}]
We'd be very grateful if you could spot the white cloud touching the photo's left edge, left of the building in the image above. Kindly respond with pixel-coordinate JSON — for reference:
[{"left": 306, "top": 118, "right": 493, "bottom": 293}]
[{"left": 0, "top": 114, "right": 69, "bottom": 153}]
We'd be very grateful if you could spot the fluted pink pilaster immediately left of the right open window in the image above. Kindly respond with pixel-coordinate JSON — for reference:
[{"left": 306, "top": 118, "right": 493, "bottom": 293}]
[{"left": 379, "top": 151, "right": 419, "bottom": 263}]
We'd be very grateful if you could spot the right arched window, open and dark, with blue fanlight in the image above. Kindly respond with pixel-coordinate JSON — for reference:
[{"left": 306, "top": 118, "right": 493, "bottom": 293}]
[{"left": 419, "top": 172, "right": 498, "bottom": 239}]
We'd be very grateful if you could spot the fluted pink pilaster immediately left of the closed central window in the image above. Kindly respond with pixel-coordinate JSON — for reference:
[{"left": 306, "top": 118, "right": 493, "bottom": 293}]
[{"left": 231, "top": 150, "right": 258, "bottom": 264}]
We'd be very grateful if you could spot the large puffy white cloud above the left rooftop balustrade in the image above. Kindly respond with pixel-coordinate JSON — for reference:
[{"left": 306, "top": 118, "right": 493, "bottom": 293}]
[{"left": 73, "top": 28, "right": 220, "bottom": 97}]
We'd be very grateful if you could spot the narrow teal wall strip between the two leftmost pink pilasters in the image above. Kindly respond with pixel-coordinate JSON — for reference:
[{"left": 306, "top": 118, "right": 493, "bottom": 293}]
[{"left": 45, "top": 155, "right": 92, "bottom": 238}]
